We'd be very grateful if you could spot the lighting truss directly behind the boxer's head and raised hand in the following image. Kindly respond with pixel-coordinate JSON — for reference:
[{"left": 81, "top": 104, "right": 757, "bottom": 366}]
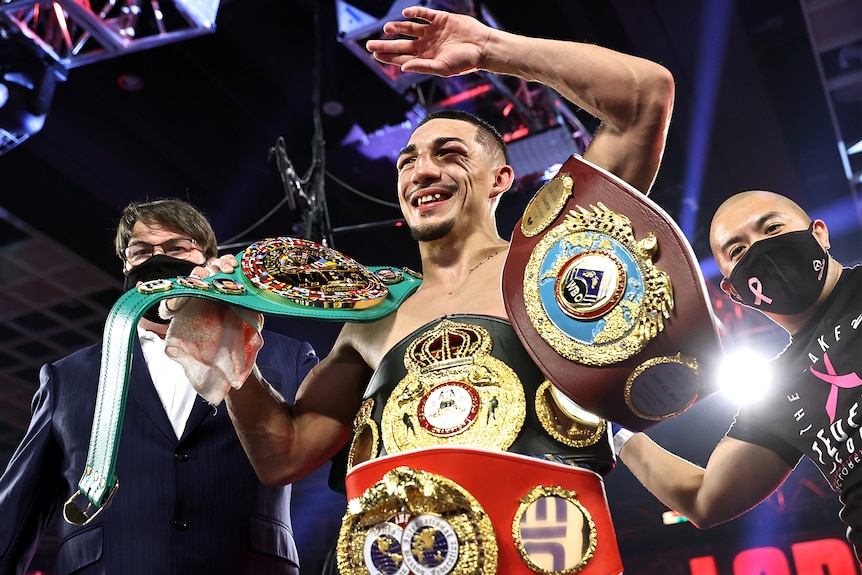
[{"left": 336, "top": 0, "right": 592, "bottom": 187}]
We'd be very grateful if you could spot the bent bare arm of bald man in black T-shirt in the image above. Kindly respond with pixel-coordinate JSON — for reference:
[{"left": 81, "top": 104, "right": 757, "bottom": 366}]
[{"left": 620, "top": 433, "right": 792, "bottom": 529}]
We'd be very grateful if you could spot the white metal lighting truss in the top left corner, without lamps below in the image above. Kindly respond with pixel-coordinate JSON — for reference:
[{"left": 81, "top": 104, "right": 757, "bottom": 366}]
[{"left": 0, "top": 0, "right": 220, "bottom": 69}]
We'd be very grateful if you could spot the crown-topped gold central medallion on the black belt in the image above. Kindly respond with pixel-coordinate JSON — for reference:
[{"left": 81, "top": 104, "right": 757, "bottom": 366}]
[{"left": 380, "top": 319, "right": 526, "bottom": 454}]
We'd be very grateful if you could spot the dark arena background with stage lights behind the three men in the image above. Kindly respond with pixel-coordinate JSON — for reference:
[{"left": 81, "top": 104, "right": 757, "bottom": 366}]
[{"left": 0, "top": 0, "right": 862, "bottom": 575}]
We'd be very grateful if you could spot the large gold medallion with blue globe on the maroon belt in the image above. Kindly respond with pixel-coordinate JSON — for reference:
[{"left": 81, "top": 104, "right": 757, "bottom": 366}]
[{"left": 524, "top": 202, "right": 674, "bottom": 366}]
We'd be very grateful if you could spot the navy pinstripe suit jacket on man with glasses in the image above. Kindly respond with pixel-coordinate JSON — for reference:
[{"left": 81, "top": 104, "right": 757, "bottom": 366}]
[{"left": 0, "top": 332, "right": 318, "bottom": 575}]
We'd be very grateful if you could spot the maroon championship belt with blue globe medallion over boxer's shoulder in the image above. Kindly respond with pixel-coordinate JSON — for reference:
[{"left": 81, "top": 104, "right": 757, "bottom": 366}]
[{"left": 503, "top": 156, "right": 722, "bottom": 431}]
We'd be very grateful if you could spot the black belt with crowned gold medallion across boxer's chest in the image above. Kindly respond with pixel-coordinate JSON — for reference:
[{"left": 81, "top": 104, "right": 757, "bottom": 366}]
[{"left": 346, "top": 314, "right": 614, "bottom": 473}]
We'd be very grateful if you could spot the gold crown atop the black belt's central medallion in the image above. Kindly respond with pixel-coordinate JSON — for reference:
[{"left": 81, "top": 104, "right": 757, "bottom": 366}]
[{"left": 404, "top": 319, "right": 493, "bottom": 372}]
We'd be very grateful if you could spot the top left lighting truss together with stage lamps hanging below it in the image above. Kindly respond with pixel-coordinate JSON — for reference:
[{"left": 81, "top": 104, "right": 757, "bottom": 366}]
[{"left": 0, "top": 0, "right": 220, "bottom": 155}]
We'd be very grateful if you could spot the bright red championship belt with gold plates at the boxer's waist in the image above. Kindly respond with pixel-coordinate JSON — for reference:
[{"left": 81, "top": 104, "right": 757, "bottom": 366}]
[{"left": 337, "top": 446, "right": 622, "bottom": 575}]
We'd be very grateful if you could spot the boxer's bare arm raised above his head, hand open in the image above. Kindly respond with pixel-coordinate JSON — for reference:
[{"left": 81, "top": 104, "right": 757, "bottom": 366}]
[{"left": 366, "top": 6, "right": 674, "bottom": 193}]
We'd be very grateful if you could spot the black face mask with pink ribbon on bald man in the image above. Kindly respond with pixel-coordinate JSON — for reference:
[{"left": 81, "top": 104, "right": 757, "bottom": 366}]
[{"left": 727, "top": 223, "right": 829, "bottom": 315}]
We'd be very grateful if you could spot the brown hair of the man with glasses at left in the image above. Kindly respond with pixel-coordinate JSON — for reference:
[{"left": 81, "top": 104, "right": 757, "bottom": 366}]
[{"left": 114, "top": 198, "right": 218, "bottom": 260}]
